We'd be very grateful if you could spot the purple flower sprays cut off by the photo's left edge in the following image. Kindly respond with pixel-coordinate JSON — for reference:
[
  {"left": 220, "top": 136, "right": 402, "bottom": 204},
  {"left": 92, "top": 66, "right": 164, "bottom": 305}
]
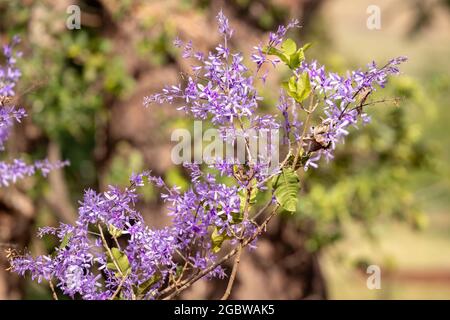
[{"left": 0, "top": 37, "right": 69, "bottom": 187}]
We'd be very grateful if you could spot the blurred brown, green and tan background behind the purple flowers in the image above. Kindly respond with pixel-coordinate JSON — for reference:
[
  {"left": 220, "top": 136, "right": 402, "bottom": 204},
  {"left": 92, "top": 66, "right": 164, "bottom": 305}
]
[{"left": 0, "top": 0, "right": 450, "bottom": 299}]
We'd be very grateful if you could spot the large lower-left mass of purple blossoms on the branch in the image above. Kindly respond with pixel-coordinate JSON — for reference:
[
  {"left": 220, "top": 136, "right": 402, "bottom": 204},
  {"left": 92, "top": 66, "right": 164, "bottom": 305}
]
[{"left": 7, "top": 169, "right": 246, "bottom": 299}]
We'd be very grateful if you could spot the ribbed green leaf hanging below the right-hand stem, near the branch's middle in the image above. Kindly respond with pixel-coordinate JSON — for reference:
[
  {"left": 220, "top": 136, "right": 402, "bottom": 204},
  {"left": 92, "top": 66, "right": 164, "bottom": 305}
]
[{"left": 272, "top": 168, "right": 300, "bottom": 212}]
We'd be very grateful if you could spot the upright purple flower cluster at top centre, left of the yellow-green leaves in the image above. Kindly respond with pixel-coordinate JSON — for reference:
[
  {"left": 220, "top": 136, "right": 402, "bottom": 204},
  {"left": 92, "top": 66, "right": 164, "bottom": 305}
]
[{"left": 144, "top": 12, "right": 260, "bottom": 127}]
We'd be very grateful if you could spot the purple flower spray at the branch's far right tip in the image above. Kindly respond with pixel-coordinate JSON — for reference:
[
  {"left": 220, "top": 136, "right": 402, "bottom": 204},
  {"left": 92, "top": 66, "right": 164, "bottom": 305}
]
[{"left": 297, "top": 57, "right": 407, "bottom": 169}]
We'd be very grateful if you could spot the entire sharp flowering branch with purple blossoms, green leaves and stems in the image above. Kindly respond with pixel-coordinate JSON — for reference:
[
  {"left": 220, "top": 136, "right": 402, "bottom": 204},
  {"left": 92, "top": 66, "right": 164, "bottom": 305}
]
[{"left": 8, "top": 12, "right": 405, "bottom": 299}]
